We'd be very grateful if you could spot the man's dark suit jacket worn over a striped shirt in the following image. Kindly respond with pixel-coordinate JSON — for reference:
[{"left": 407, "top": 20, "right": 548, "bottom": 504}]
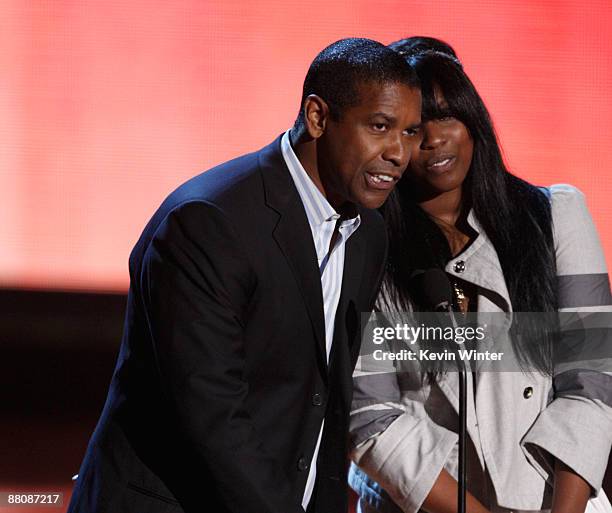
[{"left": 68, "top": 138, "right": 386, "bottom": 513}]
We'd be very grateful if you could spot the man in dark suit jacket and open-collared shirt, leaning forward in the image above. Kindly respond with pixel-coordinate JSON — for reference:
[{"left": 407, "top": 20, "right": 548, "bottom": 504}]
[{"left": 69, "top": 39, "right": 421, "bottom": 513}]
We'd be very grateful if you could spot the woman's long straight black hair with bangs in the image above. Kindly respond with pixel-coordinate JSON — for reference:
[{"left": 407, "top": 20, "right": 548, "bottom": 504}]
[{"left": 383, "top": 37, "right": 557, "bottom": 373}]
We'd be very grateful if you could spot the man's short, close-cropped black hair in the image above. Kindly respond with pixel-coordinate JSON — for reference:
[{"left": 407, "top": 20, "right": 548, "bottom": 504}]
[{"left": 294, "top": 38, "right": 419, "bottom": 131}]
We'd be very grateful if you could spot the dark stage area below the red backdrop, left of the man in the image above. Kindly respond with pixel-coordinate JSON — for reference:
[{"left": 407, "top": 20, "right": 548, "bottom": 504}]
[{"left": 0, "top": 290, "right": 612, "bottom": 513}]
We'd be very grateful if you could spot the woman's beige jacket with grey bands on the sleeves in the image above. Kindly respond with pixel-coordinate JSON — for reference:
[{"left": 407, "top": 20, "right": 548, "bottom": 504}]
[{"left": 351, "top": 185, "right": 612, "bottom": 513}]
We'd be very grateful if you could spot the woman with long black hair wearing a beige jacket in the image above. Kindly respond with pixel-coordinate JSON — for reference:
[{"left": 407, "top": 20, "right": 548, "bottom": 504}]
[{"left": 349, "top": 37, "right": 612, "bottom": 513}]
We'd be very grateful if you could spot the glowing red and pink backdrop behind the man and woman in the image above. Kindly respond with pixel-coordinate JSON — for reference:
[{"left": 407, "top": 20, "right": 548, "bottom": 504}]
[{"left": 0, "top": 0, "right": 612, "bottom": 291}]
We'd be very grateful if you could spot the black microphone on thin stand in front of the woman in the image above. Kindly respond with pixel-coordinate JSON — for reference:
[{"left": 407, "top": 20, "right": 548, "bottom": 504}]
[{"left": 418, "top": 268, "right": 467, "bottom": 513}]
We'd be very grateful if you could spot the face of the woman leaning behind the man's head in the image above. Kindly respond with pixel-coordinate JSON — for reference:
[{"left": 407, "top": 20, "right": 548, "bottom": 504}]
[{"left": 405, "top": 90, "right": 474, "bottom": 198}]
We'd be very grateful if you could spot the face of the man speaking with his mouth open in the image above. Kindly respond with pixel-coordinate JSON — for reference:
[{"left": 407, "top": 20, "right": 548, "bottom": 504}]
[{"left": 317, "top": 82, "right": 421, "bottom": 210}]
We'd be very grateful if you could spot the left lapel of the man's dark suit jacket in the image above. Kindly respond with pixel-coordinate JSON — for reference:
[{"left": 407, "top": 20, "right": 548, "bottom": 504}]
[{"left": 259, "top": 137, "right": 327, "bottom": 369}]
